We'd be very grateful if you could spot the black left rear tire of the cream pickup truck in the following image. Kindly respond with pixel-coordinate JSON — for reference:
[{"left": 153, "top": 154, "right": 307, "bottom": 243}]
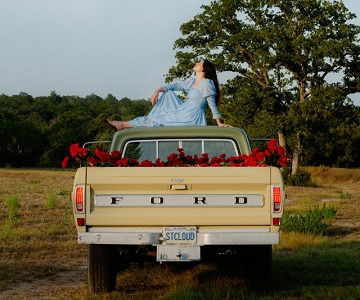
[{"left": 88, "top": 245, "right": 117, "bottom": 294}]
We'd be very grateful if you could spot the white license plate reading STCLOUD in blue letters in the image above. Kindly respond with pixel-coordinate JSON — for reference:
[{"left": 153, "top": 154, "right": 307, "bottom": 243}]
[{"left": 163, "top": 227, "right": 196, "bottom": 245}]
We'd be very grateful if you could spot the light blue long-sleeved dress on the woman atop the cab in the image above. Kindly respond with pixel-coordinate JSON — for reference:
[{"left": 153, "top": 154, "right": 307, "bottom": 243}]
[{"left": 129, "top": 78, "right": 221, "bottom": 127}]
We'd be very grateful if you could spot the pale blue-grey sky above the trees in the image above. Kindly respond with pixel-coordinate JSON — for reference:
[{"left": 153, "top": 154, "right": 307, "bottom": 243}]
[{"left": 0, "top": 0, "right": 360, "bottom": 105}]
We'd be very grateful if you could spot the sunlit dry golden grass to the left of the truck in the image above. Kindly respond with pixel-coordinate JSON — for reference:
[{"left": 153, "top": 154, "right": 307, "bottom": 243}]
[{"left": 0, "top": 169, "right": 86, "bottom": 299}]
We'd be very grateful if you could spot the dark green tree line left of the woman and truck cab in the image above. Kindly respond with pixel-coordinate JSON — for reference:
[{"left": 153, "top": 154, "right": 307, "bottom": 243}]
[{"left": 0, "top": 92, "right": 151, "bottom": 167}]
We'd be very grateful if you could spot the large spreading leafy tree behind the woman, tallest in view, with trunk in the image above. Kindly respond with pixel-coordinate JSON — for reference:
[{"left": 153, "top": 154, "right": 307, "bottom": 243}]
[{"left": 168, "top": 0, "right": 360, "bottom": 172}]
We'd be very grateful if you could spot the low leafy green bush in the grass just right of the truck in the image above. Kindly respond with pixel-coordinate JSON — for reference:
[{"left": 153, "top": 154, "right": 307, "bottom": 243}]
[{"left": 281, "top": 203, "right": 337, "bottom": 235}]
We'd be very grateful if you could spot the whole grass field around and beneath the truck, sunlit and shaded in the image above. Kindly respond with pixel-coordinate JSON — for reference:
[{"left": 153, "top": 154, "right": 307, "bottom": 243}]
[{"left": 0, "top": 167, "right": 360, "bottom": 300}]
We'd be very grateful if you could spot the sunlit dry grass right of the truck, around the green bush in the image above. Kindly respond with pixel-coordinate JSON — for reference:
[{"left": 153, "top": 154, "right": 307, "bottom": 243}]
[{"left": 285, "top": 167, "right": 360, "bottom": 241}]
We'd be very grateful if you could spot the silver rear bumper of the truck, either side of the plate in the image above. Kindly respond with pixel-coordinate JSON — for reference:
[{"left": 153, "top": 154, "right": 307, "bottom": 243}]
[{"left": 78, "top": 227, "right": 280, "bottom": 246}]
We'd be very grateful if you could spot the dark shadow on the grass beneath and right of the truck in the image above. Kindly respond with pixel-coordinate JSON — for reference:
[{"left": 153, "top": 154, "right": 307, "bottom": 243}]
[{"left": 116, "top": 241, "right": 360, "bottom": 299}]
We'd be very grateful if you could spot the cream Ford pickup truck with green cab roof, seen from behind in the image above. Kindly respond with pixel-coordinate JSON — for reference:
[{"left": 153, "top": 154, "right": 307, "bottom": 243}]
[{"left": 72, "top": 126, "right": 284, "bottom": 293}]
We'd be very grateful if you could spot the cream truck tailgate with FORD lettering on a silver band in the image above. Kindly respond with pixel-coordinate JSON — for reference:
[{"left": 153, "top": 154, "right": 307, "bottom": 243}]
[{"left": 80, "top": 167, "right": 281, "bottom": 227}]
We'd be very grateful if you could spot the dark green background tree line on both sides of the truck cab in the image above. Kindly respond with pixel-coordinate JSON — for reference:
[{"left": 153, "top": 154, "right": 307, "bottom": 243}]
[{"left": 0, "top": 88, "right": 360, "bottom": 168}]
